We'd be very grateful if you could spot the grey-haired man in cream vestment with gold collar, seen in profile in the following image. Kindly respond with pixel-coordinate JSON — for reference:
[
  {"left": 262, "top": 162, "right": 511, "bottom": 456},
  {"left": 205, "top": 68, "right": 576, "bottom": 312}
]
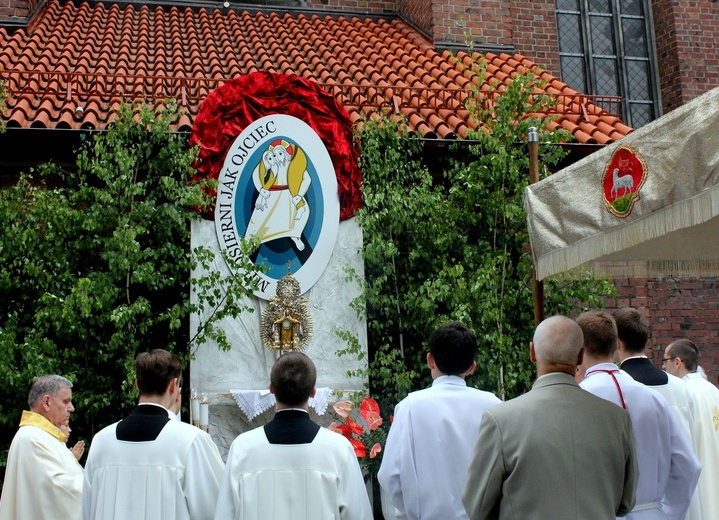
[{"left": 0, "top": 375, "right": 83, "bottom": 520}]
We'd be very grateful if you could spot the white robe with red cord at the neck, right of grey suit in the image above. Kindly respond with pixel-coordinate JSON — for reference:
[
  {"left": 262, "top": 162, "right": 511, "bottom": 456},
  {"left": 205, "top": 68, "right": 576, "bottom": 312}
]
[{"left": 580, "top": 363, "right": 701, "bottom": 520}]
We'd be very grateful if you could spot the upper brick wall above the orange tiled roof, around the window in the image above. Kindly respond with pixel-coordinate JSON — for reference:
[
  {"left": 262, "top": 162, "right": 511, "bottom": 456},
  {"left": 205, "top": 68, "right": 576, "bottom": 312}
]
[{"left": 316, "top": 0, "right": 719, "bottom": 123}]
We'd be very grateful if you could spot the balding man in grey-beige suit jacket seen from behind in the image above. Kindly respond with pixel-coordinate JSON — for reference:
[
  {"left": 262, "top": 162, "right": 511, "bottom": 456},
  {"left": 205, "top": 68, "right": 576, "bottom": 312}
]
[{"left": 462, "top": 316, "right": 637, "bottom": 520}]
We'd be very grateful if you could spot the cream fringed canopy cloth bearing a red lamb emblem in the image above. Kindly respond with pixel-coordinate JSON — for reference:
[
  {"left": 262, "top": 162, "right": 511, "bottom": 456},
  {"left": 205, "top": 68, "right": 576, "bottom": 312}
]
[{"left": 525, "top": 89, "right": 719, "bottom": 280}]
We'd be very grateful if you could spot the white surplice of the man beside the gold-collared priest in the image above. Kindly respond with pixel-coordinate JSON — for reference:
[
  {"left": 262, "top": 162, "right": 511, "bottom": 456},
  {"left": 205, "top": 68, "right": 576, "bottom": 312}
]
[{"left": 82, "top": 414, "right": 224, "bottom": 520}]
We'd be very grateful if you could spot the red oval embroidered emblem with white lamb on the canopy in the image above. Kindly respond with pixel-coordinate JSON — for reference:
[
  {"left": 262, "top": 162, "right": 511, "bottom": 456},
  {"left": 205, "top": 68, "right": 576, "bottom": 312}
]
[{"left": 602, "top": 145, "right": 647, "bottom": 218}]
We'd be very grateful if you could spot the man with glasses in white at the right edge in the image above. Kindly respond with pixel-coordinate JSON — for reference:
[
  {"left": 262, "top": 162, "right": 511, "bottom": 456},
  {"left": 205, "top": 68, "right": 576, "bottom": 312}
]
[{"left": 662, "top": 339, "right": 719, "bottom": 520}]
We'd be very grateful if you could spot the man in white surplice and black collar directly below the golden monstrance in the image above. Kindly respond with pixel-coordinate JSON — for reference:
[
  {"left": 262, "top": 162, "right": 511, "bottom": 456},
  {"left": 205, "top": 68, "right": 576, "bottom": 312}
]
[{"left": 215, "top": 351, "right": 372, "bottom": 520}]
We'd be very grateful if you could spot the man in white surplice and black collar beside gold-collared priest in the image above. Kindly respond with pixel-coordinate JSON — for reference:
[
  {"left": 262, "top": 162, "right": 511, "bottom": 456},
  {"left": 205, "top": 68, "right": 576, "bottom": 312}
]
[{"left": 82, "top": 349, "right": 224, "bottom": 520}]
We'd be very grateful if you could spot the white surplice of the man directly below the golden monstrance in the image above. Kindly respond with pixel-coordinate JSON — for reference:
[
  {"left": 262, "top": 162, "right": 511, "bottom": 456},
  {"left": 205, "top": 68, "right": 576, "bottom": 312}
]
[{"left": 215, "top": 428, "right": 372, "bottom": 520}]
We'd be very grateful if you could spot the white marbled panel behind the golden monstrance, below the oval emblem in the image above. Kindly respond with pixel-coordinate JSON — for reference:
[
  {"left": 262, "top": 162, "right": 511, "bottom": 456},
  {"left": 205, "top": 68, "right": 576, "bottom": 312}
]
[{"left": 190, "top": 219, "right": 367, "bottom": 452}]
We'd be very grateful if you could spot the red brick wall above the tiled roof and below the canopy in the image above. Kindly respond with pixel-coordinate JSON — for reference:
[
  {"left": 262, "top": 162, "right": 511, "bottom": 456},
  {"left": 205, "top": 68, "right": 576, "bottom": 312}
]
[{"left": 310, "top": 0, "right": 719, "bottom": 383}]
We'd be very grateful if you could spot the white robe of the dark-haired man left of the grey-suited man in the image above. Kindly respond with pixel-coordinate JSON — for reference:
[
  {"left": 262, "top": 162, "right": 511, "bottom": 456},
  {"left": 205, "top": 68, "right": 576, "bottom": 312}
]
[{"left": 377, "top": 376, "right": 501, "bottom": 520}]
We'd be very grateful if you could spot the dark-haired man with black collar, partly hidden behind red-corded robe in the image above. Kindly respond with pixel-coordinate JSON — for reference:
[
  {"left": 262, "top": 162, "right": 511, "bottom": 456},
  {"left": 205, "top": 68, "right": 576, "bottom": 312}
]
[{"left": 612, "top": 307, "right": 703, "bottom": 520}]
